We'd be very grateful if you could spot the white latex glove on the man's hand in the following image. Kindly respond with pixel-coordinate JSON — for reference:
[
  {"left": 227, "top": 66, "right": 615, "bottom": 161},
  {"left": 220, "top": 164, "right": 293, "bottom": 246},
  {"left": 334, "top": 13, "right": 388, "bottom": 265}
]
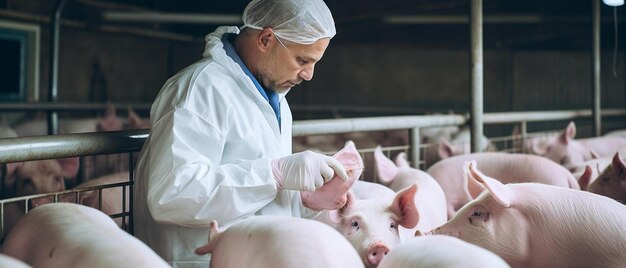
[{"left": 272, "top": 151, "right": 348, "bottom": 191}]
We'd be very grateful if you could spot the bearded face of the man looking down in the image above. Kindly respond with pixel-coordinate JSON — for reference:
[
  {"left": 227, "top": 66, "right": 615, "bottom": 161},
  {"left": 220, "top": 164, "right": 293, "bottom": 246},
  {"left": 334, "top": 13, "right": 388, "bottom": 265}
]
[{"left": 256, "top": 35, "right": 330, "bottom": 93}]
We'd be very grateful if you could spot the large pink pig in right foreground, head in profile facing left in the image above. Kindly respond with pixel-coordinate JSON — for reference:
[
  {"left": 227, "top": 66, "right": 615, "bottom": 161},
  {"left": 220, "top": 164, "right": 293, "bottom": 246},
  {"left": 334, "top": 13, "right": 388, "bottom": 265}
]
[{"left": 427, "top": 162, "right": 626, "bottom": 268}]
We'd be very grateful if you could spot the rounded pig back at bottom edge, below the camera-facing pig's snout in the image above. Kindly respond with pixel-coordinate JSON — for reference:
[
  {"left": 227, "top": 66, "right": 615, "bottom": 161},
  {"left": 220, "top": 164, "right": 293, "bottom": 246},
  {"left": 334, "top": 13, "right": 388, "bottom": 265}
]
[{"left": 378, "top": 235, "right": 510, "bottom": 268}]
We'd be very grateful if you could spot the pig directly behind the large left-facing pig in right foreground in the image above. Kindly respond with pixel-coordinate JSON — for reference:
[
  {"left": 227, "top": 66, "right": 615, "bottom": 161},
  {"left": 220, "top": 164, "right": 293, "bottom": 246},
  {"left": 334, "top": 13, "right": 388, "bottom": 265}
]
[{"left": 426, "top": 153, "right": 580, "bottom": 219}]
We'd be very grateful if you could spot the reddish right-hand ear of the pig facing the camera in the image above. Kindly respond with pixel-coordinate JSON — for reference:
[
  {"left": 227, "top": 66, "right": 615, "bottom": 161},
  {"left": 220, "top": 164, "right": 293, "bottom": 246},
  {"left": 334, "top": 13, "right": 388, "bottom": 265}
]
[{"left": 391, "top": 183, "right": 419, "bottom": 229}]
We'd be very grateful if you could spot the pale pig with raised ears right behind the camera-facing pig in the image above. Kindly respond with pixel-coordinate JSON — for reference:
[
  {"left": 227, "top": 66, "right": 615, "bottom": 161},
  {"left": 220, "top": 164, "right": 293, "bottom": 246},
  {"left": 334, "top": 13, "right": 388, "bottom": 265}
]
[{"left": 374, "top": 146, "right": 448, "bottom": 231}]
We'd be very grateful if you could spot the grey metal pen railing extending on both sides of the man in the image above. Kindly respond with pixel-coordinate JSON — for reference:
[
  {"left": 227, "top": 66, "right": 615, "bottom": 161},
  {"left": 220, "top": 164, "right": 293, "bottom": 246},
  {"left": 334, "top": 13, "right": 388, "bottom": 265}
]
[{"left": 0, "top": 109, "right": 626, "bottom": 241}]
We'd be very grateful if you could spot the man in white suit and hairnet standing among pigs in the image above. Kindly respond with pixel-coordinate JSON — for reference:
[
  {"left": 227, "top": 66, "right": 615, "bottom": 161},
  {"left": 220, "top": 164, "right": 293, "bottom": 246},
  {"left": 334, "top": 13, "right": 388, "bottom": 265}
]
[{"left": 134, "top": 0, "right": 347, "bottom": 267}]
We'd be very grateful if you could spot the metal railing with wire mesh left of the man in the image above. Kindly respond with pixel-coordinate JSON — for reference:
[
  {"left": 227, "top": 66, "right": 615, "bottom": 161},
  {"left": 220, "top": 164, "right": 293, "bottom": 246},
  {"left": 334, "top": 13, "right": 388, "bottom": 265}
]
[{"left": 0, "top": 129, "right": 149, "bottom": 238}]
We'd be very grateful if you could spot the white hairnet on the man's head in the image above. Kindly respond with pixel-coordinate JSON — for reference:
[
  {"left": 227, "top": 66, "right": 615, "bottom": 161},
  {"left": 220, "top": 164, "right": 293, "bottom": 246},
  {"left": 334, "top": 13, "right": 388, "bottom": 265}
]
[{"left": 242, "top": 0, "right": 336, "bottom": 45}]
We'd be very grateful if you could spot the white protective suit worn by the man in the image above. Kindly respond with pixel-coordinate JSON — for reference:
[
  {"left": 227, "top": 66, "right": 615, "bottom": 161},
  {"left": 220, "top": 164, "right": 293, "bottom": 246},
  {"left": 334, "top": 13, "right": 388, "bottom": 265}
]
[{"left": 133, "top": 27, "right": 317, "bottom": 268}]
